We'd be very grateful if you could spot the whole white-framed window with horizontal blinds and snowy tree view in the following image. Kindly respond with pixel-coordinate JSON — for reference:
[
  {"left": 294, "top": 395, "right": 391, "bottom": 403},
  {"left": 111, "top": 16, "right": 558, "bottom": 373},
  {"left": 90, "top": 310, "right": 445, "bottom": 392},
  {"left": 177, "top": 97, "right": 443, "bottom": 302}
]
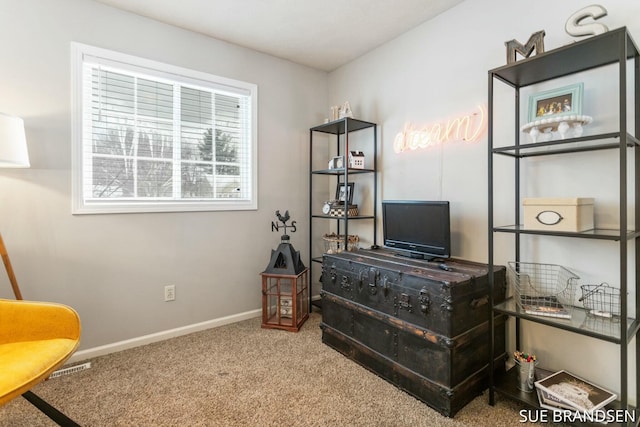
[{"left": 72, "top": 43, "right": 257, "bottom": 213}]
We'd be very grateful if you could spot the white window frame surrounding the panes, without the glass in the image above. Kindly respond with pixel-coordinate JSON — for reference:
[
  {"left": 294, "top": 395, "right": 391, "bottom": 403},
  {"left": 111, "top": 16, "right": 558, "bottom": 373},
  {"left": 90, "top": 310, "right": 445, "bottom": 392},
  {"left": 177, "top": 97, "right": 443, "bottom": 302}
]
[{"left": 71, "top": 42, "right": 258, "bottom": 214}]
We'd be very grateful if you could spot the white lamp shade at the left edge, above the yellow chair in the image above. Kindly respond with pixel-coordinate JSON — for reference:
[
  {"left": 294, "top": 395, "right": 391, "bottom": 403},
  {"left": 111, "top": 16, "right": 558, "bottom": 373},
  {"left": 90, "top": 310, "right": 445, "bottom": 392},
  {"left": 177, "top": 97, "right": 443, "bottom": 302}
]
[{"left": 0, "top": 113, "right": 29, "bottom": 168}]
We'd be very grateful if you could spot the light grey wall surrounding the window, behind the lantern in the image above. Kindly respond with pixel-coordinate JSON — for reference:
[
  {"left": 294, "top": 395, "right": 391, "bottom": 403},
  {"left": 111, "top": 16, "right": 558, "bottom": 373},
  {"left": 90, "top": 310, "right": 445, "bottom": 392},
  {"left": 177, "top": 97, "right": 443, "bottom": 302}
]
[{"left": 0, "top": 0, "right": 328, "bottom": 350}]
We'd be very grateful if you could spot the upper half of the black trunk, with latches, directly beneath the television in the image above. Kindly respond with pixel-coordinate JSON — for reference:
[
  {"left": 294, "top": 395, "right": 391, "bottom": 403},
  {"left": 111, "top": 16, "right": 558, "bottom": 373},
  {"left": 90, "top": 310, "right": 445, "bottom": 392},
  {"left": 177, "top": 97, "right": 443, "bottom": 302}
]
[{"left": 322, "top": 249, "right": 506, "bottom": 337}]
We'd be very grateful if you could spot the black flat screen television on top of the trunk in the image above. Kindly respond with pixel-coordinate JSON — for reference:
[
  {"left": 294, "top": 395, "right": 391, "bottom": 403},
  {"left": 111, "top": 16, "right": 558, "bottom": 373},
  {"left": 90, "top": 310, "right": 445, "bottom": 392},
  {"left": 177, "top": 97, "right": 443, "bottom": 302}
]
[{"left": 382, "top": 200, "right": 451, "bottom": 260}]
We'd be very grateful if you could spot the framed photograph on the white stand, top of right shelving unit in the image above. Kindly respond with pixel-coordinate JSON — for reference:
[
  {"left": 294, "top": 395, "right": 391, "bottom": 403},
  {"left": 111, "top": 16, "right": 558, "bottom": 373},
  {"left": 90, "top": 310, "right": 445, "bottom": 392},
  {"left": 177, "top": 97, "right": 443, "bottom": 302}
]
[{"left": 529, "top": 83, "right": 584, "bottom": 122}]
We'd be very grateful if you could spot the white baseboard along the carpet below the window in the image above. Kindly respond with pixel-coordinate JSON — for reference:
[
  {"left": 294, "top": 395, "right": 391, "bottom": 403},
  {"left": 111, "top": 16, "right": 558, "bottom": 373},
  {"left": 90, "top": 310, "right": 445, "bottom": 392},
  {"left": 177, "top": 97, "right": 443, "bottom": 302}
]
[{"left": 66, "top": 309, "right": 262, "bottom": 364}]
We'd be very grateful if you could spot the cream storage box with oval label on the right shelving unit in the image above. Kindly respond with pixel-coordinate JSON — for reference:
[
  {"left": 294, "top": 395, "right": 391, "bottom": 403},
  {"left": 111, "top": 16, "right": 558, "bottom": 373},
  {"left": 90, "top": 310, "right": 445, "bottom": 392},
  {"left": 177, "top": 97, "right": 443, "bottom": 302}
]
[{"left": 522, "top": 197, "right": 593, "bottom": 232}]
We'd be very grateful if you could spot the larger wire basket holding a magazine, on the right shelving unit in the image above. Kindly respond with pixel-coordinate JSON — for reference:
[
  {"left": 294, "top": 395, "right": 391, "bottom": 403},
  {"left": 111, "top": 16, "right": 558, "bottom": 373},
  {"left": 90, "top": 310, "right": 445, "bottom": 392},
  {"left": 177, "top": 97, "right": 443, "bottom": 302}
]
[{"left": 508, "top": 262, "right": 579, "bottom": 319}]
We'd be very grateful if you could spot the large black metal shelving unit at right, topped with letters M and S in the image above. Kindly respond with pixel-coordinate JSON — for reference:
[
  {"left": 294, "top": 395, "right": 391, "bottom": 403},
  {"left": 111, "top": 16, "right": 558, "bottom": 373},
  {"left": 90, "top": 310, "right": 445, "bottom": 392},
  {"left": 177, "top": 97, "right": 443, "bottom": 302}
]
[{"left": 488, "top": 27, "right": 640, "bottom": 418}]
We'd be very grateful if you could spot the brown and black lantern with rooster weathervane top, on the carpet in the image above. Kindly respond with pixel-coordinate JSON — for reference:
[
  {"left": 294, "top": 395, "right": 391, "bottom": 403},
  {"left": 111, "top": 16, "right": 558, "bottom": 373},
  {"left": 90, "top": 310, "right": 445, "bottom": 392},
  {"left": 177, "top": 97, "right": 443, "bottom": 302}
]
[{"left": 260, "top": 211, "right": 309, "bottom": 332}]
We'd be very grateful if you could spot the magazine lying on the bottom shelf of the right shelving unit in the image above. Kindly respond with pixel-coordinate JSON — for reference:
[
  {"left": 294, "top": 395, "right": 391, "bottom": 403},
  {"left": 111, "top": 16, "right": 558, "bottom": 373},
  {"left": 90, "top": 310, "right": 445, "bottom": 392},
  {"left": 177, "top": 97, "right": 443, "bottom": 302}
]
[{"left": 535, "top": 370, "right": 617, "bottom": 414}]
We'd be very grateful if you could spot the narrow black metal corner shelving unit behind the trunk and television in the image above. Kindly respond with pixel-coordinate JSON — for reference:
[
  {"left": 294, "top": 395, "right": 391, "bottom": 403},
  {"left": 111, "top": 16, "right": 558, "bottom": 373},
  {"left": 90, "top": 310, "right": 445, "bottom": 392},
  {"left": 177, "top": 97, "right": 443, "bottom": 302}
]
[{"left": 309, "top": 117, "right": 378, "bottom": 312}]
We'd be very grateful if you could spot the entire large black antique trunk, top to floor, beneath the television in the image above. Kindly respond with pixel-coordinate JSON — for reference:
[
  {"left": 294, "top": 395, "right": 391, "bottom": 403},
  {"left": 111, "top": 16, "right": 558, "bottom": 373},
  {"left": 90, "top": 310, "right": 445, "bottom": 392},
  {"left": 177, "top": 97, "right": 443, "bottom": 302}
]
[{"left": 321, "top": 250, "right": 506, "bottom": 416}]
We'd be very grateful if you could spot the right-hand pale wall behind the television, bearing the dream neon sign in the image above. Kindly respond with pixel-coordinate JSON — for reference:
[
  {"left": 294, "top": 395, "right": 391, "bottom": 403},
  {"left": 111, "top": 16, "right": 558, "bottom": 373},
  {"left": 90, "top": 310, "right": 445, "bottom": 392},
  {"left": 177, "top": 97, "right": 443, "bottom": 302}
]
[{"left": 329, "top": 0, "right": 640, "bottom": 399}]
